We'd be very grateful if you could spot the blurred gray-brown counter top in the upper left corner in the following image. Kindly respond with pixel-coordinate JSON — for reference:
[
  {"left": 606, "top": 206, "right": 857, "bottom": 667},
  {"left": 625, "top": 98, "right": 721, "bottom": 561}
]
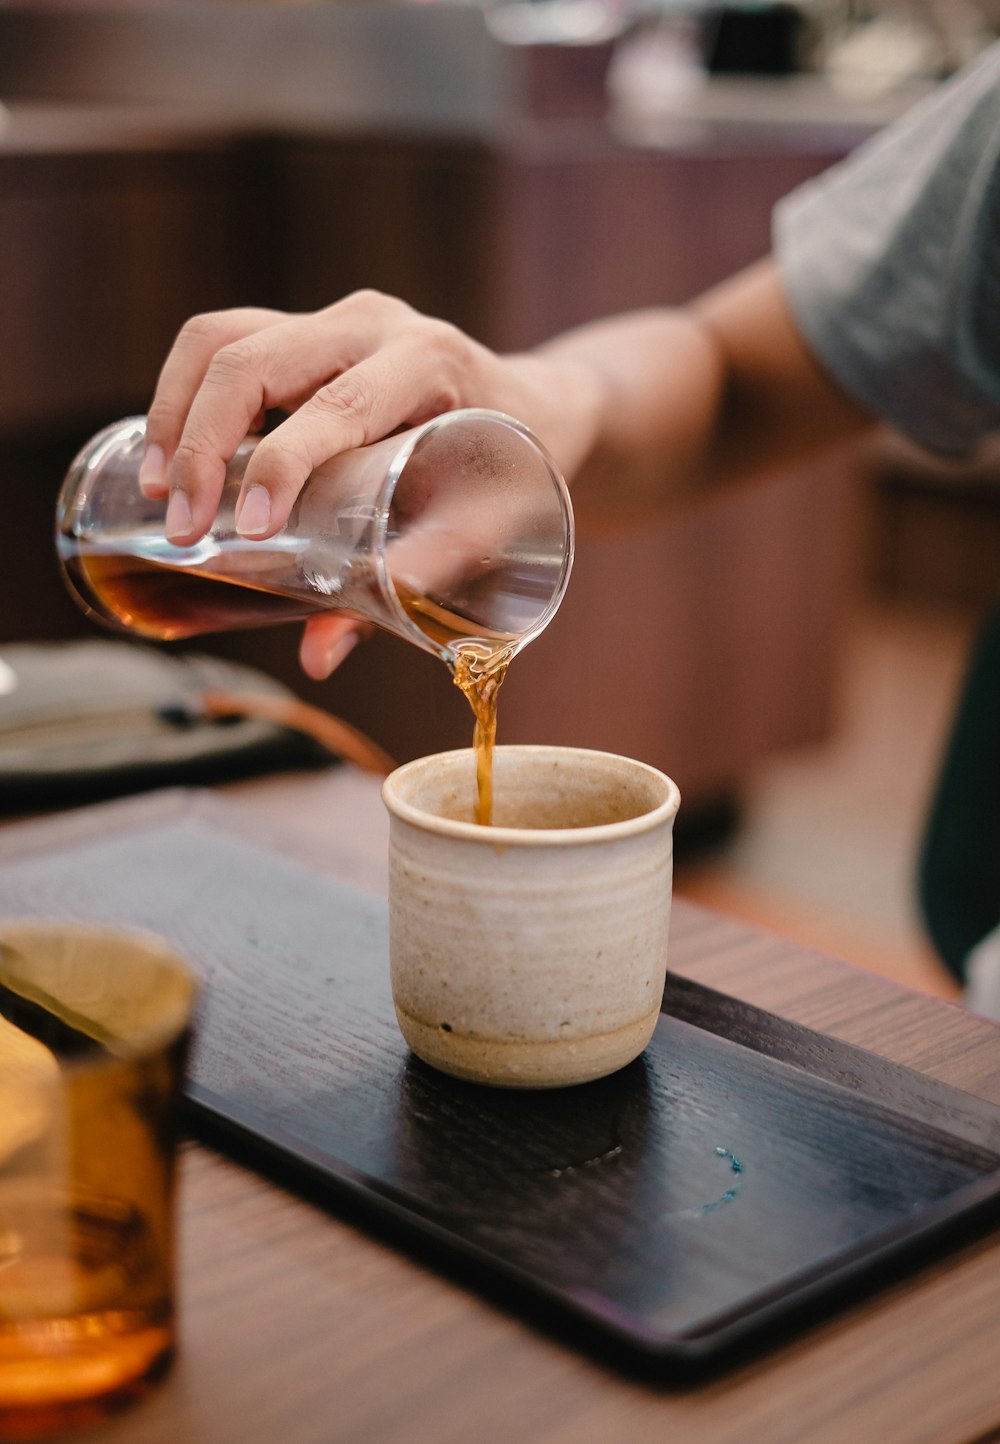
[{"left": 0, "top": 3, "right": 512, "bottom": 141}]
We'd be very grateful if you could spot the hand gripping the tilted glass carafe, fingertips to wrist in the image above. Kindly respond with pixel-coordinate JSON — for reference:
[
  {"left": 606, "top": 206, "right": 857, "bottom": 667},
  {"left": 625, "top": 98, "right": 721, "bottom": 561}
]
[{"left": 140, "top": 292, "right": 600, "bottom": 679}]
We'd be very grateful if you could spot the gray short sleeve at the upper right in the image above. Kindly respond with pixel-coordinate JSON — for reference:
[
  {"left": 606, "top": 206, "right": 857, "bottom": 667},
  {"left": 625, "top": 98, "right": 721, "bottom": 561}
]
[{"left": 775, "top": 45, "right": 1000, "bottom": 453}]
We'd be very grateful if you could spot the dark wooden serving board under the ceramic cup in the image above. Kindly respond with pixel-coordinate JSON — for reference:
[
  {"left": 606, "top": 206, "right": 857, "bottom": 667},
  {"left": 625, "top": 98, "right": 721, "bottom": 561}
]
[{"left": 0, "top": 803, "right": 1000, "bottom": 1369}]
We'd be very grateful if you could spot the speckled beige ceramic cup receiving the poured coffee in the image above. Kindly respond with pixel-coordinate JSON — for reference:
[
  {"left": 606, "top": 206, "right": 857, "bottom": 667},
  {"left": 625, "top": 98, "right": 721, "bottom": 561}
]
[{"left": 382, "top": 747, "right": 680, "bottom": 1087}]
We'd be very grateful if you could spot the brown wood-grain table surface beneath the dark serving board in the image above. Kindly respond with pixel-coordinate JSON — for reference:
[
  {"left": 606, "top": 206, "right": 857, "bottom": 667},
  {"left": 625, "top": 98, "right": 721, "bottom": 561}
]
[{"left": 27, "top": 768, "right": 1000, "bottom": 1444}]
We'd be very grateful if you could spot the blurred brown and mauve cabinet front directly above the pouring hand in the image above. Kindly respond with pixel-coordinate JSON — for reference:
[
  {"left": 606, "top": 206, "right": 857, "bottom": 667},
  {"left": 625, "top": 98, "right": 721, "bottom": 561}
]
[{"left": 272, "top": 124, "right": 837, "bottom": 349}]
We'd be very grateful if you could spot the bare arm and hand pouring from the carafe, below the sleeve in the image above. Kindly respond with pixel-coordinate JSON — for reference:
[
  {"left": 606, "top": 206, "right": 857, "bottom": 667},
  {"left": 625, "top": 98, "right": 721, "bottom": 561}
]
[{"left": 143, "top": 261, "right": 872, "bottom": 676}]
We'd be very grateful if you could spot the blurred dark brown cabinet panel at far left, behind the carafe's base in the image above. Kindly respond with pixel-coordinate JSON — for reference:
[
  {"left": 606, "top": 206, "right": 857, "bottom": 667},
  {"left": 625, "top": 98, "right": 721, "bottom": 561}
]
[{"left": 0, "top": 133, "right": 253, "bottom": 640}]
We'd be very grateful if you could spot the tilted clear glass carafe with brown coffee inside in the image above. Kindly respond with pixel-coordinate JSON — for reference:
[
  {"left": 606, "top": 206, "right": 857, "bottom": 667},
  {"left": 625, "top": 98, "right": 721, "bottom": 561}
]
[{"left": 56, "top": 410, "right": 573, "bottom": 666}]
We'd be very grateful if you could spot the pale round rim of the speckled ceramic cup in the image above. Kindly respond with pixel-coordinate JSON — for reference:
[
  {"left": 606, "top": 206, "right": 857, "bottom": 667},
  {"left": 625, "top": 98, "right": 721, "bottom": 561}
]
[{"left": 382, "top": 742, "right": 681, "bottom": 848}]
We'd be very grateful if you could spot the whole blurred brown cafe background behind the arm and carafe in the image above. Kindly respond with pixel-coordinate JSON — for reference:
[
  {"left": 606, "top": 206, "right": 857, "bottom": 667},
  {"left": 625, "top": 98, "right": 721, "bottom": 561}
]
[{"left": 0, "top": 0, "right": 997, "bottom": 843}]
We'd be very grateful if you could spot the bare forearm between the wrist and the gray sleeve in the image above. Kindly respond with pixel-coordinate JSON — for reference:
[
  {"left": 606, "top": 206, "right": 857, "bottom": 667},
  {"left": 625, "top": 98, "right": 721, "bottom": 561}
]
[{"left": 519, "top": 261, "right": 873, "bottom": 523}]
